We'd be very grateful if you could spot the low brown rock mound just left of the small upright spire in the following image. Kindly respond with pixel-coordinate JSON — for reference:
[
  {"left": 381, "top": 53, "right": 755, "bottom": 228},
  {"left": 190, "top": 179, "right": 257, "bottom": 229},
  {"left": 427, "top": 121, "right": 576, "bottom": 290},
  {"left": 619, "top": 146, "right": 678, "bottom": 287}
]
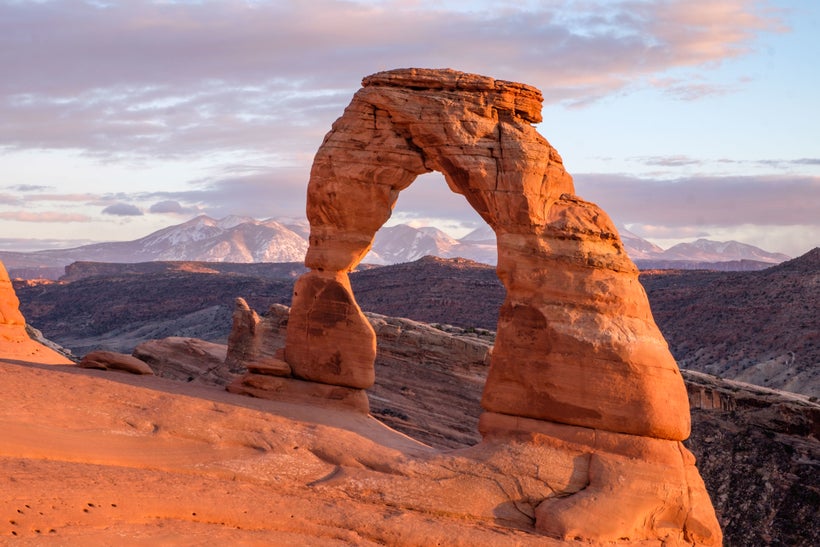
[{"left": 132, "top": 336, "right": 236, "bottom": 386}]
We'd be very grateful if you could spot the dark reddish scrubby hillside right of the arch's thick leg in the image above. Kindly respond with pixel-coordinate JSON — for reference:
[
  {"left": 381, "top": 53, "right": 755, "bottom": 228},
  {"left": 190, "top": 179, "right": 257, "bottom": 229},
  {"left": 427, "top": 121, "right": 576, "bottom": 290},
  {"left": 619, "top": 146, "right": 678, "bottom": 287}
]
[{"left": 642, "top": 248, "right": 820, "bottom": 397}]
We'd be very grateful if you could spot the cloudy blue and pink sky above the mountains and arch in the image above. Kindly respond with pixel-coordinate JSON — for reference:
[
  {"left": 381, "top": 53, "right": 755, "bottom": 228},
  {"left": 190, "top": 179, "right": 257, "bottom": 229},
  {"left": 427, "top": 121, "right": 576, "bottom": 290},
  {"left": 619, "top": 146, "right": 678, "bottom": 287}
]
[{"left": 0, "top": 0, "right": 820, "bottom": 256}]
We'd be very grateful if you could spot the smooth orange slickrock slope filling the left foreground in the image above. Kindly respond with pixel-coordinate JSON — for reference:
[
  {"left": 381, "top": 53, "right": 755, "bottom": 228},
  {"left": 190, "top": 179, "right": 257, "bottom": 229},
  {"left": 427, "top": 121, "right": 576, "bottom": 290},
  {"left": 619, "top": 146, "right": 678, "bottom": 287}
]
[{"left": 0, "top": 362, "right": 564, "bottom": 546}]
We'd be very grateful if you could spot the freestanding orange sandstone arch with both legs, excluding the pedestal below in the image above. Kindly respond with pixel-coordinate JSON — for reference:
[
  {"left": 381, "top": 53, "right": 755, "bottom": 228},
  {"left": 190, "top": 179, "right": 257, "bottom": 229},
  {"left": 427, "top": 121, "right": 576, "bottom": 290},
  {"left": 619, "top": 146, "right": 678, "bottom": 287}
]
[{"left": 285, "top": 69, "right": 689, "bottom": 440}]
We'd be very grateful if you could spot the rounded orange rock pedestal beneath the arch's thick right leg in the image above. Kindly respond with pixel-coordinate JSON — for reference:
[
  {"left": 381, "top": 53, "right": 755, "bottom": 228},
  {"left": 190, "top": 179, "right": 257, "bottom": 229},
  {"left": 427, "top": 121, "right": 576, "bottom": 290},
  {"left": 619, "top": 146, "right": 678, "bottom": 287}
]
[{"left": 479, "top": 412, "right": 722, "bottom": 545}]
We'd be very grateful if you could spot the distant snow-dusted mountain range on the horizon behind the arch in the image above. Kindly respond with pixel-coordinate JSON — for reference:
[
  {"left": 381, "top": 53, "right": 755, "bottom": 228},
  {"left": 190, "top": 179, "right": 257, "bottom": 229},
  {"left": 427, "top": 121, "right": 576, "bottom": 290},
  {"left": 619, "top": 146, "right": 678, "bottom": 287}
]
[{"left": 0, "top": 215, "right": 789, "bottom": 279}]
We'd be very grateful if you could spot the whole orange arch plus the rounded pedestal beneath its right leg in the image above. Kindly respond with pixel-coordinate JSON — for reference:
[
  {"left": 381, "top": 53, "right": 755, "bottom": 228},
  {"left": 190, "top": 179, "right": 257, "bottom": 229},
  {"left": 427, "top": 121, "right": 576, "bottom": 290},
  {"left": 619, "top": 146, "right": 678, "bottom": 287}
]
[{"left": 266, "top": 69, "right": 721, "bottom": 544}]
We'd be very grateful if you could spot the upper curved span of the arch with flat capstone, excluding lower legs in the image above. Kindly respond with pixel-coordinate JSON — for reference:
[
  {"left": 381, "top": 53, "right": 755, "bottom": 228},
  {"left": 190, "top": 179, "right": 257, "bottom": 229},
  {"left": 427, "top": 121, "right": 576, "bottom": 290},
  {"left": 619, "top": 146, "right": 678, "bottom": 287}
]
[{"left": 306, "top": 69, "right": 574, "bottom": 271}]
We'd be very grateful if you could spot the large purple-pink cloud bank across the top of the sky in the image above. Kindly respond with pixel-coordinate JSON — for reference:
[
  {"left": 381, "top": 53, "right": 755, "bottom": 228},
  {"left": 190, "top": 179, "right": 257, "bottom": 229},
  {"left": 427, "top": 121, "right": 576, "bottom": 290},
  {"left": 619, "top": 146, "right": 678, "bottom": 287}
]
[{"left": 0, "top": 0, "right": 782, "bottom": 158}]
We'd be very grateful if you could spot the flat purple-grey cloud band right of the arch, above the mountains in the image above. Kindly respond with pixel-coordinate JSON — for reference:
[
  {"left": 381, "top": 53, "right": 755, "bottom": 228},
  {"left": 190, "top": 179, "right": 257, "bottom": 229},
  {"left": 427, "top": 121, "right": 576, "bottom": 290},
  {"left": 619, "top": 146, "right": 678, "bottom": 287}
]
[{"left": 574, "top": 174, "right": 820, "bottom": 226}]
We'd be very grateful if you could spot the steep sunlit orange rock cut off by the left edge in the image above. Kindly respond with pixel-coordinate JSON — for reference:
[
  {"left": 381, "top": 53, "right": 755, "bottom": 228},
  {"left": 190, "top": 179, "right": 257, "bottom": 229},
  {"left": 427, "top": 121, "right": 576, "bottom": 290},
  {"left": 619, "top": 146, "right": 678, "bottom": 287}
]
[{"left": 0, "top": 262, "right": 71, "bottom": 365}]
